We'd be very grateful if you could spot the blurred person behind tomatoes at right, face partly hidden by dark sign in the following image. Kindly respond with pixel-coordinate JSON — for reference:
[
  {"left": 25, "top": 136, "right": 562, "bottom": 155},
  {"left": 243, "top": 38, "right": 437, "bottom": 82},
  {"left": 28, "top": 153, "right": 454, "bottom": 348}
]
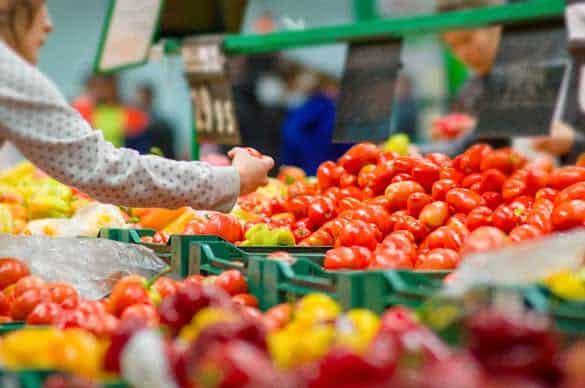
[{"left": 418, "top": 0, "right": 585, "bottom": 163}]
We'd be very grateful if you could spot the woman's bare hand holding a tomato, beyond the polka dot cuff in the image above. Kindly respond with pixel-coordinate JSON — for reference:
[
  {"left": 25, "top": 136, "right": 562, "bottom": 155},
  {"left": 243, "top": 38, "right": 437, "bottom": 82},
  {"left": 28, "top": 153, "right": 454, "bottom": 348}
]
[{"left": 228, "top": 147, "right": 274, "bottom": 195}]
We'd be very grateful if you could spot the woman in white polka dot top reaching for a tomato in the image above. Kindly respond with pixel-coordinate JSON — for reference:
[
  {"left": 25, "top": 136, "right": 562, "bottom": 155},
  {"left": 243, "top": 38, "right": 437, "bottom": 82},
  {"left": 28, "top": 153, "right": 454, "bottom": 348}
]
[{"left": 0, "top": 0, "right": 273, "bottom": 211}]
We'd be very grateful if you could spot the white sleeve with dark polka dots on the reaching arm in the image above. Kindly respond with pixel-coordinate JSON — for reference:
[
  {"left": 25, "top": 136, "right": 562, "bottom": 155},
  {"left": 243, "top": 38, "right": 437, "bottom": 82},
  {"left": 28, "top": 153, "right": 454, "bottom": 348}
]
[{"left": 0, "top": 42, "right": 240, "bottom": 211}]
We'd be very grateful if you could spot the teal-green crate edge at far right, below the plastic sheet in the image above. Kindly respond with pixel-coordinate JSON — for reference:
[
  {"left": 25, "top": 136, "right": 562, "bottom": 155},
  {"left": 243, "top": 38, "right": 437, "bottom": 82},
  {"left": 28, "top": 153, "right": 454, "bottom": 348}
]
[{"left": 524, "top": 285, "right": 585, "bottom": 335}]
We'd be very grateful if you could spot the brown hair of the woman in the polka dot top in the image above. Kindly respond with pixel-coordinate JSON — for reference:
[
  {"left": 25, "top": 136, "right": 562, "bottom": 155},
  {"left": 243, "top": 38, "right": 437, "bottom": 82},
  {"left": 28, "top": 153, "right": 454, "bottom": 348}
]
[{"left": 0, "top": 0, "right": 43, "bottom": 49}]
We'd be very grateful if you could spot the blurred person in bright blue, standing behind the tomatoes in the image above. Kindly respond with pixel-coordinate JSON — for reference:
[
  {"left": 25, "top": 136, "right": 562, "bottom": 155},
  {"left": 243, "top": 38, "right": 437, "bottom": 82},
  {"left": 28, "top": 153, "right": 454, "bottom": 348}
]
[{"left": 280, "top": 70, "right": 351, "bottom": 176}]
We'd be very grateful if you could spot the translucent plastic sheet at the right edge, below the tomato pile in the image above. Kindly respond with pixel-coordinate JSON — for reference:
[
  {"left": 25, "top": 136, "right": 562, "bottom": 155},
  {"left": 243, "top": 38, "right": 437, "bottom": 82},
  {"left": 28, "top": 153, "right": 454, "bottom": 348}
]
[{"left": 444, "top": 229, "right": 585, "bottom": 297}]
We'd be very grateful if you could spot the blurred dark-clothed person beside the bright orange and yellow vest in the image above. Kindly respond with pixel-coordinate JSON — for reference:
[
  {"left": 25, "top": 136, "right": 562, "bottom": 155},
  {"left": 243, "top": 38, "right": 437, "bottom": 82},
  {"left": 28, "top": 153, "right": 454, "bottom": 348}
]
[{"left": 135, "top": 84, "right": 176, "bottom": 159}]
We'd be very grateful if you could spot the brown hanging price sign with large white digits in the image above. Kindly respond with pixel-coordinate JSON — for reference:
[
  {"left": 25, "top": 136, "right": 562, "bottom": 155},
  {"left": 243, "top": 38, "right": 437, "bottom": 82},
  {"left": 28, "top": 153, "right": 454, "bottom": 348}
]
[{"left": 182, "top": 36, "right": 240, "bottom": 144}]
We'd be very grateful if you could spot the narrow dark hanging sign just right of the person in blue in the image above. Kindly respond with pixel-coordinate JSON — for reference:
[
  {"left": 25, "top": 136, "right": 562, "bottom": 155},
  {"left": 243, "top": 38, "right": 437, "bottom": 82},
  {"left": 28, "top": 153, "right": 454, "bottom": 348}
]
[{"left": 333, "top": 40, "right": 402, "bottom": 143}]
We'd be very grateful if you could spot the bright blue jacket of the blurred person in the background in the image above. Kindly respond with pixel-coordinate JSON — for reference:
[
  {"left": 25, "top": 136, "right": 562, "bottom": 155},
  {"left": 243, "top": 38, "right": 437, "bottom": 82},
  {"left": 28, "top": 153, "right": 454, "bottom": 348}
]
[{"left": 281, "top": 94, "right": 351, "bottom": 176}]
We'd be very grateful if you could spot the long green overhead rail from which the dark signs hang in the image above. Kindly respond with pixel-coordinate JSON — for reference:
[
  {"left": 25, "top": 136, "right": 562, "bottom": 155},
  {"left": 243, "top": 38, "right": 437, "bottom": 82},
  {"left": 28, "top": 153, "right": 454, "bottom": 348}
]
[{"left": 224, "top": 0, "right": 565, "bottom": 54}]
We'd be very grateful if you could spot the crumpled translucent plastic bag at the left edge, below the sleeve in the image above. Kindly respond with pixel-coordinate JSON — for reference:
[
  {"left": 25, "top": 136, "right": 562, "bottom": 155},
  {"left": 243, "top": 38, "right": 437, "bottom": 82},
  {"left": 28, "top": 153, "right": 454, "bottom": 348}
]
[{"left": 0, "top": 234, "right": 167, "bottom": 299}]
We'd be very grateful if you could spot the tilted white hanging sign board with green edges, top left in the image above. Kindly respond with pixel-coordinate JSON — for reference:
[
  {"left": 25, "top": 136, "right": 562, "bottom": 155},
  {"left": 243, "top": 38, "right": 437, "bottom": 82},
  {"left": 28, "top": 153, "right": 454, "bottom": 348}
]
[{"left": 94, "top": 0, "right": 164, "bottom": 72}]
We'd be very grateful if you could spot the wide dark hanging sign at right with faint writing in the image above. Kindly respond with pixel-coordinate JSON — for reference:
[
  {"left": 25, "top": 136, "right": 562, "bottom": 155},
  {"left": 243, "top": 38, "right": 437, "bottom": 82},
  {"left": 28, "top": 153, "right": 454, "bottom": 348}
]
[{"left": 478, "top": 21, "right": 568, "bottom": 138}]
